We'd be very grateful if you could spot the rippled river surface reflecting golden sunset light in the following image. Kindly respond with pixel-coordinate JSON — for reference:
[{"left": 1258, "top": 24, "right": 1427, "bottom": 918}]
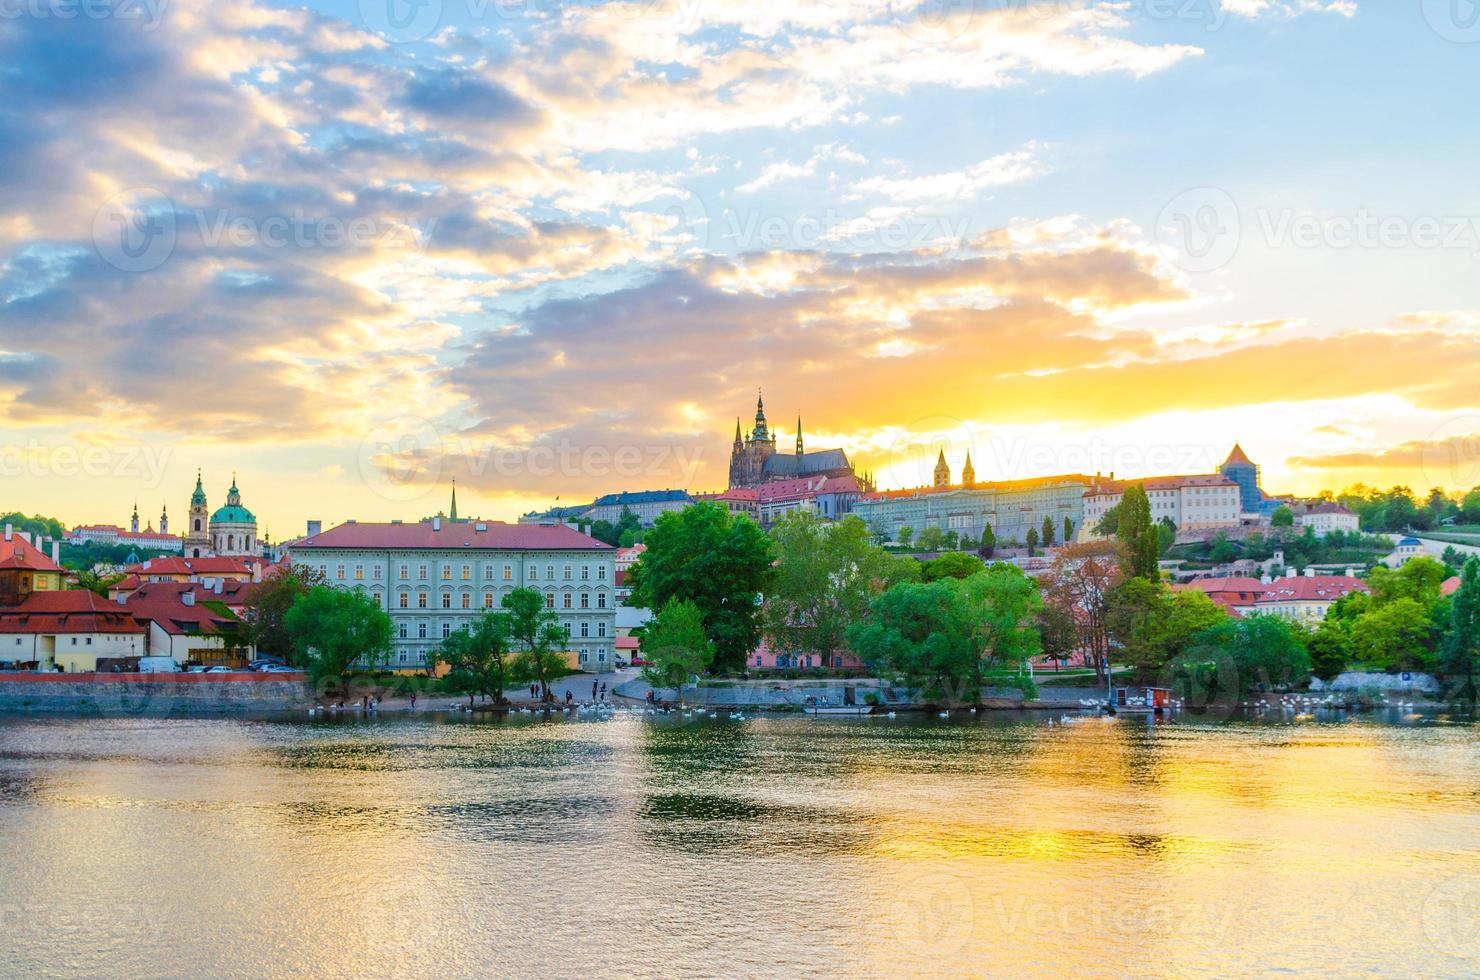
[{"left": 0, "top": 715, "right": 1480, "bottom": 977}]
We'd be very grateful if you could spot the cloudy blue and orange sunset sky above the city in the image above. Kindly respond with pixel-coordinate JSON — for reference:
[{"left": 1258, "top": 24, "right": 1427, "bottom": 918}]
[{"left": 0, "top": 0, "right": 1480, "bottom": 537}]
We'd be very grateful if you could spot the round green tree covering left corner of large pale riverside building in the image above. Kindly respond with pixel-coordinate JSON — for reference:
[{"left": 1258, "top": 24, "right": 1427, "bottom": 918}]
[{"left": 283, "top": 585, "right": 391, "bottom": 697}]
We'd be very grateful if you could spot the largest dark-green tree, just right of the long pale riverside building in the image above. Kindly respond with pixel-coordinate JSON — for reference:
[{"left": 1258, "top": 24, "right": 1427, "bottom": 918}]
[{"left": 628, "top": 502, "right": 774, "bottom": 669}]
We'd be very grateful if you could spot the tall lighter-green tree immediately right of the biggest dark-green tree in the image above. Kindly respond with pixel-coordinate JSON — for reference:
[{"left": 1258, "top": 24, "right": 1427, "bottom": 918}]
[{"left": 761, "top": 511, "right": 911, "bottom": 663}]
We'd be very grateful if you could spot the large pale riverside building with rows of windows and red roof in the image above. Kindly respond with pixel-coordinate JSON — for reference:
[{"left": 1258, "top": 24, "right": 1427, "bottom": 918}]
[{"left": 290, "top": 518, "right": 617, "bottom": 671}]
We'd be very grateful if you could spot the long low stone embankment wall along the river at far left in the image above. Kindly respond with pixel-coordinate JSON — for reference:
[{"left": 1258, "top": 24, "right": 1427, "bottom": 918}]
[{"left": 0, "top": 672, "right": 312, "bottom": 715}]
